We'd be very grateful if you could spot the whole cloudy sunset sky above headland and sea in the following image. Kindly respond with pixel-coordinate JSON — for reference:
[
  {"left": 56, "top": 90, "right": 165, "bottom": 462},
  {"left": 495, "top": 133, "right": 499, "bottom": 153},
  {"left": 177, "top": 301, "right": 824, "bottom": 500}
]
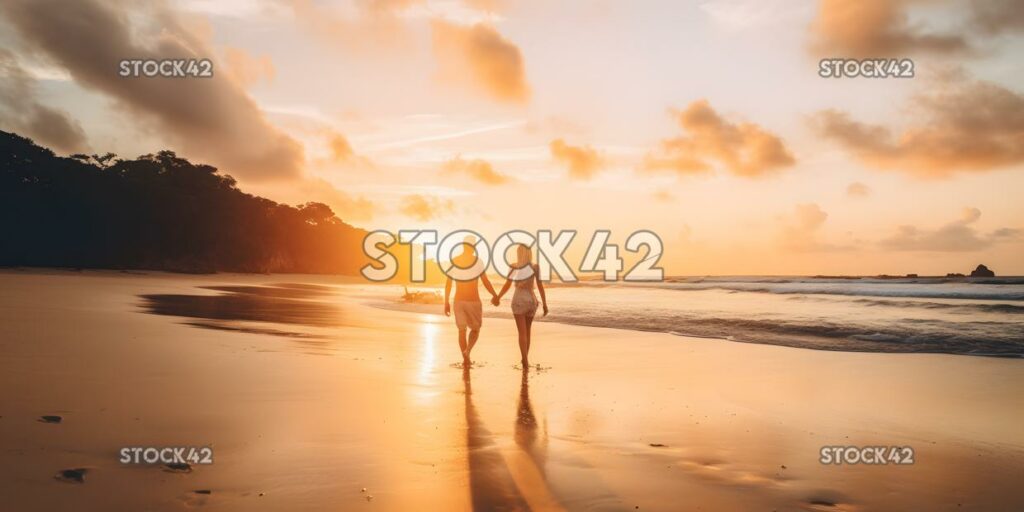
[{"left": 0, "top": 0, "right": 1024, "bottom": 275}]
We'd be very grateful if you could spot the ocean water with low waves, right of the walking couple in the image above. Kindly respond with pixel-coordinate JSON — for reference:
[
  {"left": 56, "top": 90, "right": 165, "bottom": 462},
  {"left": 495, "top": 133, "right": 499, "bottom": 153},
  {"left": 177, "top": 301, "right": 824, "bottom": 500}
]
[{"left": 536, "top": 276, "right": 1024, "bottom": 357}]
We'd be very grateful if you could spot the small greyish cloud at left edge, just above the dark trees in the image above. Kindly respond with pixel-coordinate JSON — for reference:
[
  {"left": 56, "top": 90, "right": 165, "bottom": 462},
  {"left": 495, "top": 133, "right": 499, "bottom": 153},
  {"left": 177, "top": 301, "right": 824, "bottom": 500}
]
[{"left": 0, "top": 48, "right": 88, "bottom": 153}]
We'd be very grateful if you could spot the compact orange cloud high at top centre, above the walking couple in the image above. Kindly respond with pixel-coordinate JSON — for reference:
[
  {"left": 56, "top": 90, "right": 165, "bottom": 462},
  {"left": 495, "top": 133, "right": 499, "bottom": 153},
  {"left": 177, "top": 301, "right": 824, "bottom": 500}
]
[{"left": 431, "top": 19, "right": 529, "bottom": 102}]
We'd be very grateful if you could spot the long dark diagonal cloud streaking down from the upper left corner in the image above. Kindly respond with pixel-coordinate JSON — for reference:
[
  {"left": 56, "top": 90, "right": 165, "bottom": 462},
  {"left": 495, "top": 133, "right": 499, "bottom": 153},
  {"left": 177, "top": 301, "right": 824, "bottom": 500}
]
[{"left": 0, "top": 0, "right": 304, "bottom": 180}]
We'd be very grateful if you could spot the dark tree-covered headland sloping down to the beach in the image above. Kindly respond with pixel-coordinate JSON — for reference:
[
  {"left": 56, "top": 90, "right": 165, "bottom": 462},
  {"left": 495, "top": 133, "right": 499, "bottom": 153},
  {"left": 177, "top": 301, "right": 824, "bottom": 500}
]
[{"left": 0, "top": 131, "right": 400, "bottom": 274}]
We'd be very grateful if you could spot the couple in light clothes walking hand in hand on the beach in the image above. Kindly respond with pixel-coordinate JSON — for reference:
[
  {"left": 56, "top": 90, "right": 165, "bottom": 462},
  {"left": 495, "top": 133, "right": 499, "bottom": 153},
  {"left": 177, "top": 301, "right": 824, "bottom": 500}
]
[{"left": 444, "top": 240, "right": 548, "bottom": 370}]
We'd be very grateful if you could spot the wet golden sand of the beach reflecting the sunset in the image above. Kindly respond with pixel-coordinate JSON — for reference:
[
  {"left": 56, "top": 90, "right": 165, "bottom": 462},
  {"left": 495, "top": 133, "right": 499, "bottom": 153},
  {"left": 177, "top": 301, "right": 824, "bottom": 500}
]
[{"left": 0, "top": 270, "right": 1024, "bottom": 511}]
